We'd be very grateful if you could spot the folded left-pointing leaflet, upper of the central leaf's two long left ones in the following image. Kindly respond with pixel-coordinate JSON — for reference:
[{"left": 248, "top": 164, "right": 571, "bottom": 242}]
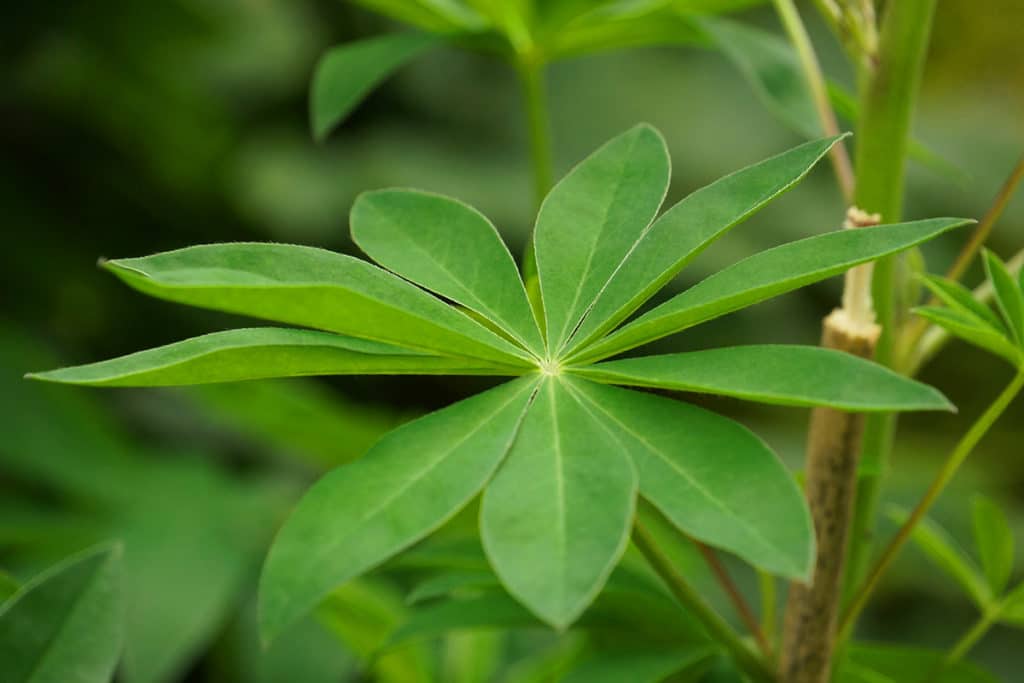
[{"left": 103, "top": 243, "right": 528, "bottom": 365}]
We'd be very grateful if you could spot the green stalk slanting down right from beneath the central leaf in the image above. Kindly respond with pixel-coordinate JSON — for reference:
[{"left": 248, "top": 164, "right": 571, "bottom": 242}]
[{"left": 633, "top": 521, "right": 775, "bottom": 683}]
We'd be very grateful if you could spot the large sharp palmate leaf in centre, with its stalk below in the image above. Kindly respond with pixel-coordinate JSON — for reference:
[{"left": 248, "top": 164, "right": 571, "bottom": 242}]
[{"left": 25, "top": 126, "right": 968, "bottom": 680}]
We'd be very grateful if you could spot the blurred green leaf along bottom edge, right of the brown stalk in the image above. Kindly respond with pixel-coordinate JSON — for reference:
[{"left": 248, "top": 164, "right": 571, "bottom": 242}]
[{"left": 838, "top": 644, "right": 998, "bottom": 683}]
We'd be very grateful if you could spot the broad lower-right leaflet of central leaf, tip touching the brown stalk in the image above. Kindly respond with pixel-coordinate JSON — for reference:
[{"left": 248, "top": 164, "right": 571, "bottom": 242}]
[{"left": 573, "top": 382, "right": 814, "bottom": 580}]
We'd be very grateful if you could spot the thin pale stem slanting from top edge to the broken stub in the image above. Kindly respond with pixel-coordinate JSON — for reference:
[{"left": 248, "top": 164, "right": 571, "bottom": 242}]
[{"left": 774, "top": 0, "right": 854, "bottom": 205}]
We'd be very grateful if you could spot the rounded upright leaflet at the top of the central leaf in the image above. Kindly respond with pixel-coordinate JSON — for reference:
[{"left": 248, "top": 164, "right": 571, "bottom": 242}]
[{"left": 534, "top": 125, "right": 669, "bottom": 356}]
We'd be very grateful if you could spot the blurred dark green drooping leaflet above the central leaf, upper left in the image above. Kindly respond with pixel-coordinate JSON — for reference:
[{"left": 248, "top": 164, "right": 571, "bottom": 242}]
[{"left": 309, "top": 33, "right": 440, "bottom": 140}]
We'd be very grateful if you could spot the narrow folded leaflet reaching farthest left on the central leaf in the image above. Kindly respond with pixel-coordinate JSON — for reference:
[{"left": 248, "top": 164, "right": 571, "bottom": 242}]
[{"left": 29, "top": 328, "right": 523, "bottom": 386}]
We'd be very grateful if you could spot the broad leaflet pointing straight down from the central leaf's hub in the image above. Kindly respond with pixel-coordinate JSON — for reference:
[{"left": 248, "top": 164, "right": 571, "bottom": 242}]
[{"left": 480, "top": 378, "right": 636, "bottom": 629}]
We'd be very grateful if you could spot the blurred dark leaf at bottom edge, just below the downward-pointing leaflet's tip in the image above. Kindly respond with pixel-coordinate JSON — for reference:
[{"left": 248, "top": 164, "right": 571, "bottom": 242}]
[{"left": 561, "top": 645, "right": 717, "bottom": 683}]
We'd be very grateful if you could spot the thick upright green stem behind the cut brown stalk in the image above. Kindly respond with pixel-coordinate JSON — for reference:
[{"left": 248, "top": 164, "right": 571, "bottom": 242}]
[{"left": 847, "top": 0, "right": 936, "bottom": 610}]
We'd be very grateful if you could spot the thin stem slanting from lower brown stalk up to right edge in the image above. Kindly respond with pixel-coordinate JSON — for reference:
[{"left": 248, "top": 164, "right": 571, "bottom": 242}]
[{"left": 840, "top": 368, "right": 1024, "bottom": 636}]
